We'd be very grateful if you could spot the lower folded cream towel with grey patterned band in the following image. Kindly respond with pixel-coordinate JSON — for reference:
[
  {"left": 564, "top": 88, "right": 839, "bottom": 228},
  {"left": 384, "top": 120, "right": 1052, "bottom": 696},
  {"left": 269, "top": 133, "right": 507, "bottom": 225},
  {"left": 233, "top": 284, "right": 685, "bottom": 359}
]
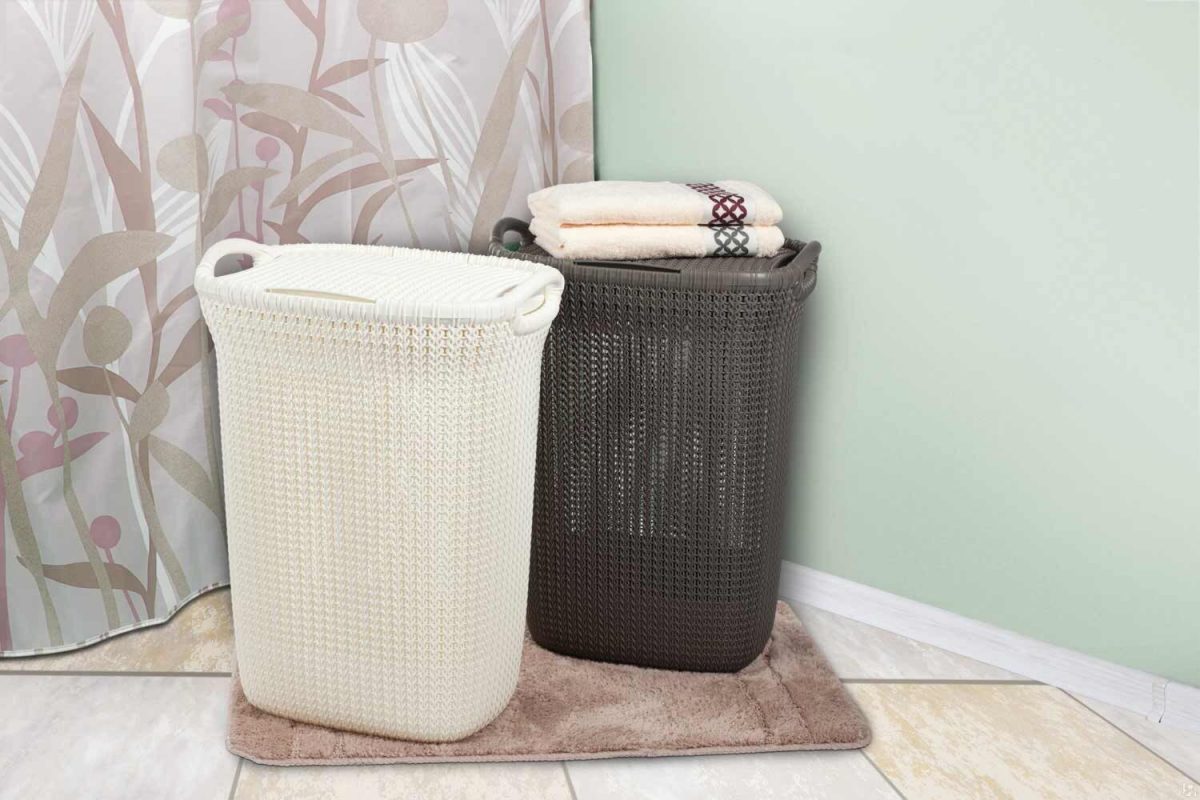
[{"left": 529, "top": 217, "right": 784, "bottom": 259}]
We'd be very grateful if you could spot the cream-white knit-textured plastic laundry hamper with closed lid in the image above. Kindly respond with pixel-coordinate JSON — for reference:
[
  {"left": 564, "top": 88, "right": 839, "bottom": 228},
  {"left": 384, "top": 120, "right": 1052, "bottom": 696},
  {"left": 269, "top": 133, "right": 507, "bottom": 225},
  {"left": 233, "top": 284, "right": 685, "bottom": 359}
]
[{"left": 196, "top": 240, "right": 563, "bottom": 741}]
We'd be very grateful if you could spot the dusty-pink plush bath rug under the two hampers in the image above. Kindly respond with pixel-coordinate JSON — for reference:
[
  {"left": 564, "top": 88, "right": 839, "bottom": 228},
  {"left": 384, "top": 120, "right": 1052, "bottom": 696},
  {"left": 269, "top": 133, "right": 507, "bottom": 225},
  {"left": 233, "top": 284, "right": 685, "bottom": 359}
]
[{"left": 228, "top": 603, "right": 871, "bottom": 765}]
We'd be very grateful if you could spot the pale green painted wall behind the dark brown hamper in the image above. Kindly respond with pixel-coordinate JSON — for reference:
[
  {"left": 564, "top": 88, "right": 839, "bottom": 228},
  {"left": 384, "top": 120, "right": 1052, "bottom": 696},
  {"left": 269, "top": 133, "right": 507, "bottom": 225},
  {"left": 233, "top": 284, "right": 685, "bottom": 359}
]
[{"left": 594, "top": 0, "right": 1200, "bottom": 685}]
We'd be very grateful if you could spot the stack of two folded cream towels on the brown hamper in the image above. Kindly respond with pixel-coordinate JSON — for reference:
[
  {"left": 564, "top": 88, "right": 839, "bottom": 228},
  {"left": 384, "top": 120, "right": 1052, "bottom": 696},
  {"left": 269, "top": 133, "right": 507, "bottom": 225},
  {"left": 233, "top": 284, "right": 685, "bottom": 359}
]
[{"left": 529, "top": 181, "right": 784, "bottom": 260}]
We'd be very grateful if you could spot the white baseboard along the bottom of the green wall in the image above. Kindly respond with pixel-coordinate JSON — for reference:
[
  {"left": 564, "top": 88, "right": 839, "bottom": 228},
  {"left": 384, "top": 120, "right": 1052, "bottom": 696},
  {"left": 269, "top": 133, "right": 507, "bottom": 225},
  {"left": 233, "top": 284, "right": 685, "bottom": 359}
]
[{"left": 779, "top": 561, "right": 1200, "bottom": 730}]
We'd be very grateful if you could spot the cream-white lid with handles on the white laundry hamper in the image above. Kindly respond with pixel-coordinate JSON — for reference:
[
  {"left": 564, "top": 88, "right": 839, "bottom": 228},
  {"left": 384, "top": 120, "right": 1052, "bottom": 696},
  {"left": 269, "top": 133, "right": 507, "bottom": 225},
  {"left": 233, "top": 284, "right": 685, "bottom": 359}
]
[{"left": 196, "top": 239, "right": 563, "bottom": 330}]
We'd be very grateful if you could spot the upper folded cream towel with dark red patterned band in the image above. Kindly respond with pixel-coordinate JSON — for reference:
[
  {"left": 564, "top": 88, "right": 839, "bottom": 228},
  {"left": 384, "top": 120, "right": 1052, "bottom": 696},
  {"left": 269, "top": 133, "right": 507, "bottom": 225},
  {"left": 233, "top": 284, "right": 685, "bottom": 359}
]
[{"left": 529, "top": 181, "right": 784, "bottom": 225}]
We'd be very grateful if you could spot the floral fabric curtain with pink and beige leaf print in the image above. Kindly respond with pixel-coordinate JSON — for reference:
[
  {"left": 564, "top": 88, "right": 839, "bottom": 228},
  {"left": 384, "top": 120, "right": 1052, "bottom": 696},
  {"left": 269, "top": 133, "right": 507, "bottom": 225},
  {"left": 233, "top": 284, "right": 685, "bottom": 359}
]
[{"left": 0, "top": 0, "right": 592, "bottom": 655}]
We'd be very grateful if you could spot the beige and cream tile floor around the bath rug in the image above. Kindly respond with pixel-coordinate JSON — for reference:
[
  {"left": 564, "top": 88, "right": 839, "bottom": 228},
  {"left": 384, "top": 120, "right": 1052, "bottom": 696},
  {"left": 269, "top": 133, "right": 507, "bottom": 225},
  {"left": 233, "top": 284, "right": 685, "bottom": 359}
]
[{"left": 0, "top": 590, "right": 1200, "bottom": 800}]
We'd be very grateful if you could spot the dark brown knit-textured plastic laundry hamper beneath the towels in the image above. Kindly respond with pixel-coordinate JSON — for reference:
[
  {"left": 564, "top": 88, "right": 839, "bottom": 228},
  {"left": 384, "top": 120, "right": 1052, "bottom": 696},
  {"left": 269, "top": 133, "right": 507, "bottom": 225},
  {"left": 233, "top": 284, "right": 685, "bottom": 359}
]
[{"left": 492, "top": 218, "right": 821, "bottom": 672}]
